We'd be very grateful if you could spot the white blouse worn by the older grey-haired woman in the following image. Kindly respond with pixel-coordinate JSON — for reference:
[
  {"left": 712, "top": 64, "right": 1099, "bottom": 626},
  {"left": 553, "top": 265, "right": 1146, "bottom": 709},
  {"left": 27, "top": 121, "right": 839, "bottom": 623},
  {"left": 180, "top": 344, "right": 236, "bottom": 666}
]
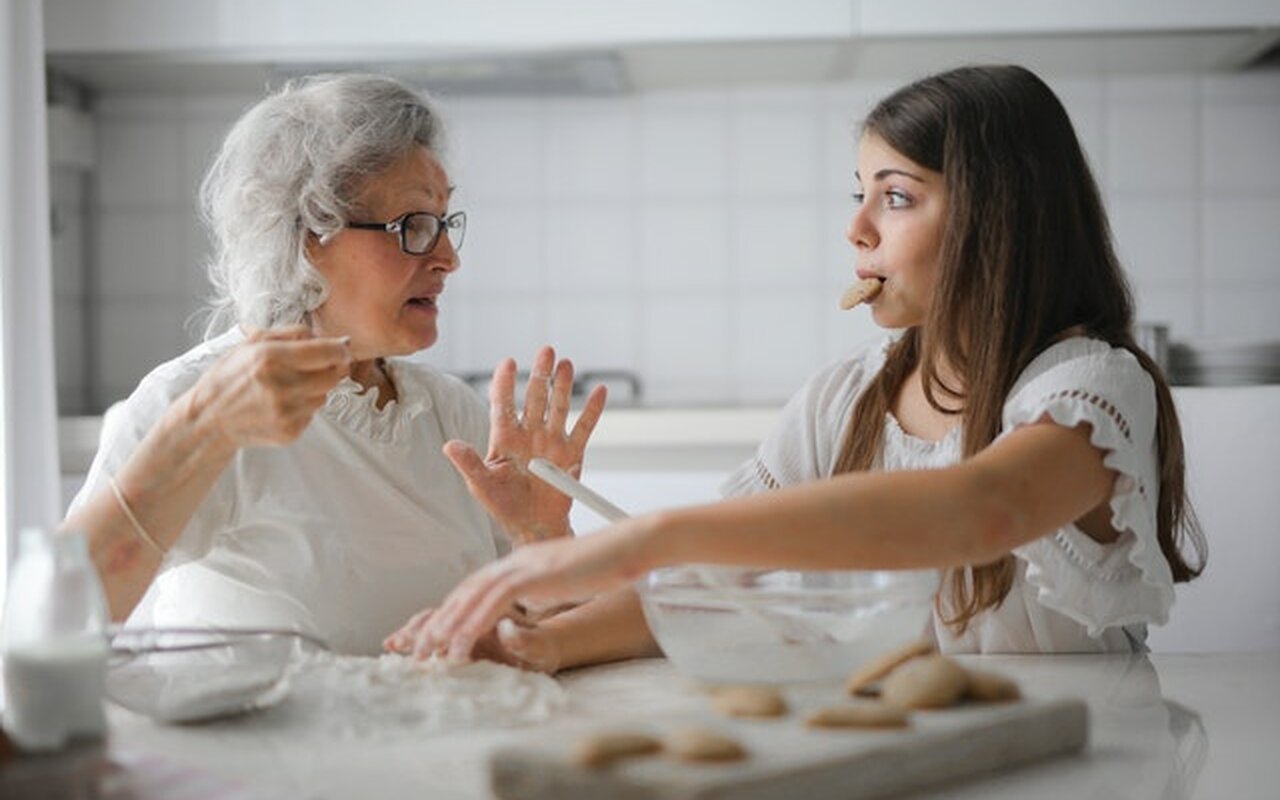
[{"left": 72, "top": 330, "right": 509, "bottom": 654}]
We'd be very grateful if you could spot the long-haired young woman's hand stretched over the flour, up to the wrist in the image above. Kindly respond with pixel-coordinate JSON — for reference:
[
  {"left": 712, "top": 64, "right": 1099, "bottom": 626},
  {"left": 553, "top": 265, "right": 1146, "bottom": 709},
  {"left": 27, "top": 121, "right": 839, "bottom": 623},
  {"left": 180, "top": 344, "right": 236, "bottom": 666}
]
[{"left": 412, "top": 517, "right": 658, "bottom": 660}]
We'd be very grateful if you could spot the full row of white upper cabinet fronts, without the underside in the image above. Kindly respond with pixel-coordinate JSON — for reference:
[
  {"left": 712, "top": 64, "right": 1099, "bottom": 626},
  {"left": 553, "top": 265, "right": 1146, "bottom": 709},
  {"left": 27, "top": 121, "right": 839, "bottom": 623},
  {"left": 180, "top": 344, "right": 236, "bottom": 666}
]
[{"left": 45, "top": 0, "right": 1280, "bottom": 60}]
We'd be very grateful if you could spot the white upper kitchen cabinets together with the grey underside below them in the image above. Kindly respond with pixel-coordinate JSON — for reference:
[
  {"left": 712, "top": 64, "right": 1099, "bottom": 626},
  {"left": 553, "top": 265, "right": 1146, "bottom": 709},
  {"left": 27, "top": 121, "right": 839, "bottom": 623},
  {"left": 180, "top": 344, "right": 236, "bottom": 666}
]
[{"left": 45, "top": 0, "right": 1280, "bottom": 95}]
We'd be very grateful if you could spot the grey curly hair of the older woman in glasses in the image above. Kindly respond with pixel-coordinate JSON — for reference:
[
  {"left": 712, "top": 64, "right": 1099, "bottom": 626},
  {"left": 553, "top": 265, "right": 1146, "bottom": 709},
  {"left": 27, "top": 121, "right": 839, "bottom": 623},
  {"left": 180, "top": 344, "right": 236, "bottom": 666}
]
[{"left": 200, "top": 74, "right": 444, "bottom": 335}]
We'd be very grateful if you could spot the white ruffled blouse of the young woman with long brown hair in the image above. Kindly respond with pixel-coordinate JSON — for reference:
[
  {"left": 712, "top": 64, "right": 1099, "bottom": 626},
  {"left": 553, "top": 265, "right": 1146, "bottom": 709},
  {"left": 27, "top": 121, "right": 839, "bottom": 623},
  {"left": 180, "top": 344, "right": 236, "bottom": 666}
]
[{"left": 722, "top": 337, "right": 1174, "bottom": 653}]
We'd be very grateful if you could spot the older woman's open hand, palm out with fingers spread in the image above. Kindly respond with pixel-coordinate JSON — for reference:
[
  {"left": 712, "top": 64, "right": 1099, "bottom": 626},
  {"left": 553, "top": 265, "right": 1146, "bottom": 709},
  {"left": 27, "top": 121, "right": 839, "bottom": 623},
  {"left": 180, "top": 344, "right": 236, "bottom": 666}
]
[{"left": 444, "top": 347, "right": 605, "bottom": 545}]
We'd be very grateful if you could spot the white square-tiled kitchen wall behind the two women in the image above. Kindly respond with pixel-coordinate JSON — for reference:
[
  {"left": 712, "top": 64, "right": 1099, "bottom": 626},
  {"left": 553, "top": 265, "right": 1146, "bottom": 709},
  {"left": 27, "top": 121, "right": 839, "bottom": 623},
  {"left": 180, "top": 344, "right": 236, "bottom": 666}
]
[{"left": 51, "top": 72, "right": 1280, "bottom": 415}]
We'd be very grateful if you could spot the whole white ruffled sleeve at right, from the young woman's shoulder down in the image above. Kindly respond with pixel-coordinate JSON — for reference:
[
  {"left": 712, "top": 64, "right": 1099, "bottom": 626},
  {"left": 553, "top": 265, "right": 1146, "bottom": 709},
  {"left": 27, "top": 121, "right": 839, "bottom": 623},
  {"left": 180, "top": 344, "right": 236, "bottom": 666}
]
[{"left": 1002, "top": 338, "right": 1174, "bottom": 636}]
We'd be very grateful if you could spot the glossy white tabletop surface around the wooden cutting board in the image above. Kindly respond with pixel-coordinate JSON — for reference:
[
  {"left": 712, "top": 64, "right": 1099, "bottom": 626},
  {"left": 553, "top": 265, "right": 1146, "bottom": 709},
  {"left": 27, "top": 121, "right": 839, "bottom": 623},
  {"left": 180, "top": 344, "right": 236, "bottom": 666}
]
[{"left": 12, "top": 653, "right": 1280, "bottom": 800}]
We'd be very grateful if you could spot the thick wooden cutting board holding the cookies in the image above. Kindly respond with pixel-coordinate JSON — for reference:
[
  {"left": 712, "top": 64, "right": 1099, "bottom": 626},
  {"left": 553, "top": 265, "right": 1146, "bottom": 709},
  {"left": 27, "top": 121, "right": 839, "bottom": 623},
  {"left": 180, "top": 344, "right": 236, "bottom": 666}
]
[{"left": 489, "top": 700, "right": 1088, "bottom": 800}]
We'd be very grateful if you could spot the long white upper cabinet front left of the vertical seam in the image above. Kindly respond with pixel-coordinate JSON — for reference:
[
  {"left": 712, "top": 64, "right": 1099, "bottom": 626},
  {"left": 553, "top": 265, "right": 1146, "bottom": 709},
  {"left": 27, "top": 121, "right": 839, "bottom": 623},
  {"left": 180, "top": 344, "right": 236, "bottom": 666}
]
[{"left": 45, "top": 0, "right": 854, "bottom": 60}]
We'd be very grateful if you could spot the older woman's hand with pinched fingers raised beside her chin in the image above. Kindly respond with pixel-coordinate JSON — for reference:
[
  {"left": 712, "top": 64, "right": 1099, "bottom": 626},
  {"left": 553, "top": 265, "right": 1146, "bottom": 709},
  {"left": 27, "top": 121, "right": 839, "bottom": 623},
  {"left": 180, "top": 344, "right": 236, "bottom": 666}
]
[{"left": 189, "top": 325, "right": 351, "bottom": 448}]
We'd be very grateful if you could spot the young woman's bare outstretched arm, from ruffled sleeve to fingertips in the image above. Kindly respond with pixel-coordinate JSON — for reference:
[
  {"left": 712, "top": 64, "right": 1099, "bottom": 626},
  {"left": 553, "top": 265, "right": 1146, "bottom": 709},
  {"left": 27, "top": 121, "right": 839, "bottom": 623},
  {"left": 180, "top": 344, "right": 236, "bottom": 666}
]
[{"left": 417, "top": 420, "right": 1116, "bottom": 658}]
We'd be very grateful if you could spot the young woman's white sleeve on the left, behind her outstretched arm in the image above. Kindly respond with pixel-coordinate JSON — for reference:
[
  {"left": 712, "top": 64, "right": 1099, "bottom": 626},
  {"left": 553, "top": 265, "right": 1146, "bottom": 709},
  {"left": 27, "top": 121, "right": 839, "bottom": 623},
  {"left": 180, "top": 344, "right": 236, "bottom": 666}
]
[{"left": 719, "top": 338, "right": 893, "bottom": 497}]
